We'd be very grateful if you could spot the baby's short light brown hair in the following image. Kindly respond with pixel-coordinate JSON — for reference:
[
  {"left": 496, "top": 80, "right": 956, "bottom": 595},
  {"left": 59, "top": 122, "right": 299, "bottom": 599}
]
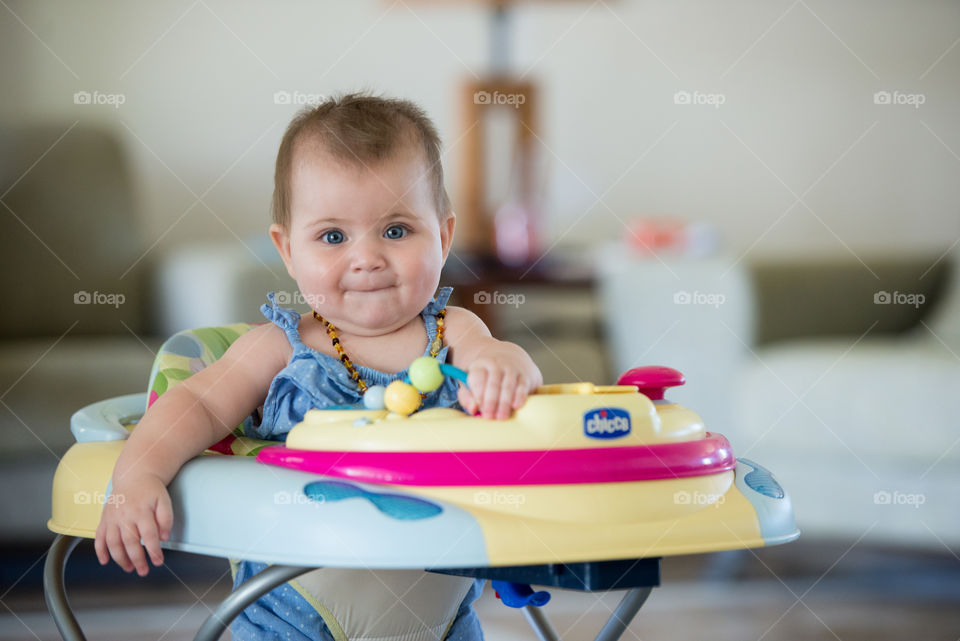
[{"left": 271, "top": 93, "right": 450, "bottom": 229}]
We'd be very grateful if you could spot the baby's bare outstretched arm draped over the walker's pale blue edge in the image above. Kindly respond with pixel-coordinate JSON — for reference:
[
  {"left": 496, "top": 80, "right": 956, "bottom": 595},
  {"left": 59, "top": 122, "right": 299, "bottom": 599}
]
[{"left": 95, "top": 325, "right": 289, "bottom": 576}]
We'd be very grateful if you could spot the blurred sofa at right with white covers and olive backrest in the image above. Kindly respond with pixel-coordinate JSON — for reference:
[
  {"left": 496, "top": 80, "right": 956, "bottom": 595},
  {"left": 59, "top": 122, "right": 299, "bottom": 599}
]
[{"left": 600, "top": 242, "right": 960, "bottom": 551}]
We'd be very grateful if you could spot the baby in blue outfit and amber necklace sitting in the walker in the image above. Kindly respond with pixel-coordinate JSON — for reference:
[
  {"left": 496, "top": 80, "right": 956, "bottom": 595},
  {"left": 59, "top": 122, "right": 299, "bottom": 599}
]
[{"left": 96, "top": 95, "right": 543, "bottom": 641}]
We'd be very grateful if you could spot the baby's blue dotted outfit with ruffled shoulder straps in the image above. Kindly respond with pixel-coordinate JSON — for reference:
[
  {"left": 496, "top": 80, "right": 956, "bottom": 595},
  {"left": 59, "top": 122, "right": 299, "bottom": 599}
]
[{"left": 230, "top": 287, "right": 483, "bottom": 641}]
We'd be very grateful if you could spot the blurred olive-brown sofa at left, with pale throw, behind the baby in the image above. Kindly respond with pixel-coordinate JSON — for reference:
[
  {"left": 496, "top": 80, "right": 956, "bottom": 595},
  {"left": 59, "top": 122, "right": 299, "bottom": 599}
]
[{"left": 0, "top": 122, "right": 289, "bottom": 543}]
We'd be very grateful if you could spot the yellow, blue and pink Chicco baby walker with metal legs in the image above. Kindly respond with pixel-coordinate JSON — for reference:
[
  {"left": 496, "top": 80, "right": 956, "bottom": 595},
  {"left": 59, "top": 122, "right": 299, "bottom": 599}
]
[{"left": 44, "top": 330, "right": 799, "bottom": 641}]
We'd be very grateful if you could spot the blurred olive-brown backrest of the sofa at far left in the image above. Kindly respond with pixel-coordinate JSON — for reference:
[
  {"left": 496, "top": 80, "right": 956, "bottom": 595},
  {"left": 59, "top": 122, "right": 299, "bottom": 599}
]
[{"left": 0, "top": 123, "right": 145, "bottom": 339}]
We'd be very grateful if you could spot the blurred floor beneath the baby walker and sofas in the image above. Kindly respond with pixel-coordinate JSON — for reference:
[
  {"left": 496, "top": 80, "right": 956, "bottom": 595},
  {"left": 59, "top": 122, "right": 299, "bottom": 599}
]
[{"left": 0, "top": 540, "right": 960, "bottom": 641}]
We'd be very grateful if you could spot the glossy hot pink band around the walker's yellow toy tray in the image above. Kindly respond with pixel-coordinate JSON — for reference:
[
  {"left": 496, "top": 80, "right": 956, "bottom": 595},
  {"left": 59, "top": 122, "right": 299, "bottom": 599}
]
[{"left": 257, "top": 432, "right": 737, "bottom": 486}]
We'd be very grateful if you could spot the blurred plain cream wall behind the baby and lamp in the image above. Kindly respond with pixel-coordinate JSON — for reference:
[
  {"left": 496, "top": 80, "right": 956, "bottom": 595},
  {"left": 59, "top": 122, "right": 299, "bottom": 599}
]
[{"left": 0, "top": 0, "right": 960, "bottom": 255}]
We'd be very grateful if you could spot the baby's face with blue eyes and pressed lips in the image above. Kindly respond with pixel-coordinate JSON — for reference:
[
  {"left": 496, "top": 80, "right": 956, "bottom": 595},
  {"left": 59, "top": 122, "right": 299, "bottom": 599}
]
[{"left": 270, "top": 143, "right": 454, "bottom": 336}]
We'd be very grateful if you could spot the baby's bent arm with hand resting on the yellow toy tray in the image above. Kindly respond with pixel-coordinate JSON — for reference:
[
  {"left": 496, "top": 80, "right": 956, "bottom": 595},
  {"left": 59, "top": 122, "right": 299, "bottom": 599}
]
[{"left": 444, "top": 307, "right": 543, "bottom": 419}]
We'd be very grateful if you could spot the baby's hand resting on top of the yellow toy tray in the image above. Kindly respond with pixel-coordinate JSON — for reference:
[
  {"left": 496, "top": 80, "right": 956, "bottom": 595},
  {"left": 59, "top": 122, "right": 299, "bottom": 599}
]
[{"left": 457, "top": 348, "right": 543, "bottom": 420}]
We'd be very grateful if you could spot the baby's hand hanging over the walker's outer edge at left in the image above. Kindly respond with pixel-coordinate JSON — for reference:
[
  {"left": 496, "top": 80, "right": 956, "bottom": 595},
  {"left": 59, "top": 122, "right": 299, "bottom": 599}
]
[{"left": 94, "top": 475, "right": 173, "bottom": 576}]
